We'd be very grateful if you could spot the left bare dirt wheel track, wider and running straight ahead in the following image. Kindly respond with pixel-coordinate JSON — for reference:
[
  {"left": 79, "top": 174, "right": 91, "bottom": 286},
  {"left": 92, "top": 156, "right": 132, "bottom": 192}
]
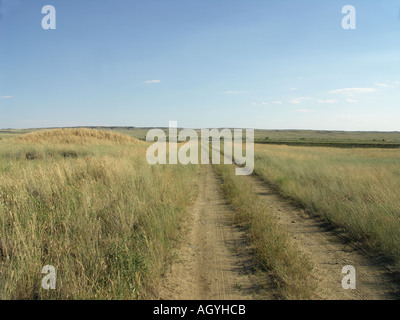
[{"left": 159, "top": 165, "right": 274, "bottom": 300}]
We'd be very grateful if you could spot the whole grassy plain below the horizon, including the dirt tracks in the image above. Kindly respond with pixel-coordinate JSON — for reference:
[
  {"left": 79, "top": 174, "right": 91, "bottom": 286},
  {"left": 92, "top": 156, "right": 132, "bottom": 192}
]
[{"left": 0, "top": 127, "right": 400, "bottom": 300}]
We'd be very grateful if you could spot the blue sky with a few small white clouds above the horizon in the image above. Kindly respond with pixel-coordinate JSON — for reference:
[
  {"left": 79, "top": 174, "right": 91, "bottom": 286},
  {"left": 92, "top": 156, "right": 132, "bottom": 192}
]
[{"left": 0, "top": 0, "right": 400, "bottom": 131}]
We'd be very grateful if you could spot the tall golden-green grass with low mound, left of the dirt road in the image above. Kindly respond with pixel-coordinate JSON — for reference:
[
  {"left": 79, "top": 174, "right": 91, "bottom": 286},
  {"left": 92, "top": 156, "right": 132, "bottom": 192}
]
[{"left": 0, "top": 129, "right": 197, "bottom": 299}]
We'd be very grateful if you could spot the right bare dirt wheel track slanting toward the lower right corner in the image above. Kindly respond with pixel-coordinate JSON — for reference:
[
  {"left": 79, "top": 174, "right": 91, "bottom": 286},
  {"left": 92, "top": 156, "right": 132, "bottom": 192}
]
[{"left": 243, "top": 175, "right": 400, "bottom": 300}]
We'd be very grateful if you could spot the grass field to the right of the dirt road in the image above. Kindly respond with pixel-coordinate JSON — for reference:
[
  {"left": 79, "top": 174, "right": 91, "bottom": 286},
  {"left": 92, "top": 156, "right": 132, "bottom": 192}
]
[{"left": 254, "top": 145, "right": 400, "bottom": 269}]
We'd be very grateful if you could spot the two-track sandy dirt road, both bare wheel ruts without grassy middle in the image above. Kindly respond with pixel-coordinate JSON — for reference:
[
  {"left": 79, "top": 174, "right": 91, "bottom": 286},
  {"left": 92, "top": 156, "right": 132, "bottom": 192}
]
[{"left": 159, "top": 165, "right": 400, "bottom": 300}]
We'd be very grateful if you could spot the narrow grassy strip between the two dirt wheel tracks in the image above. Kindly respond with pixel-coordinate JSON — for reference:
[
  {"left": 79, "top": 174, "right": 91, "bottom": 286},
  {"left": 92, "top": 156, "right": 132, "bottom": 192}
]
[{"left": 214, "top": 165, "right": 316, "bottom": 300}]
